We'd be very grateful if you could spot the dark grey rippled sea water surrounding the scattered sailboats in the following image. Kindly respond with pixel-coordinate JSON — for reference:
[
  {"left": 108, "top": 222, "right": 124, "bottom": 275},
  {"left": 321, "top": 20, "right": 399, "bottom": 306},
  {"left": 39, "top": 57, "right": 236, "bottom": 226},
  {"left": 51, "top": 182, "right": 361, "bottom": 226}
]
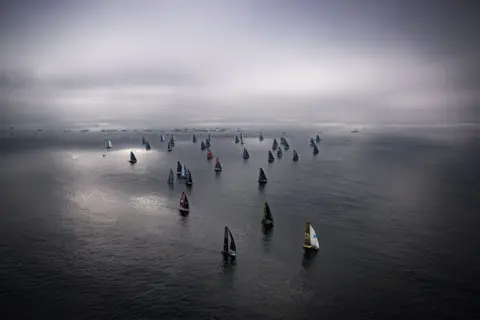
[{"left": 0, "top": 126, "right": 480, "bottom": 319}]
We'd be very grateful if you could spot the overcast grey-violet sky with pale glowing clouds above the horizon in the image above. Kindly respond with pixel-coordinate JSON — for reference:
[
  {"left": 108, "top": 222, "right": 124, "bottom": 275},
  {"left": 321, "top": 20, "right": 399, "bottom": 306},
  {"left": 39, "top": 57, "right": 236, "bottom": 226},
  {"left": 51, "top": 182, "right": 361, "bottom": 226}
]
[{"left": 0, "top": 0, "right": 480, "bottom": 123}]
